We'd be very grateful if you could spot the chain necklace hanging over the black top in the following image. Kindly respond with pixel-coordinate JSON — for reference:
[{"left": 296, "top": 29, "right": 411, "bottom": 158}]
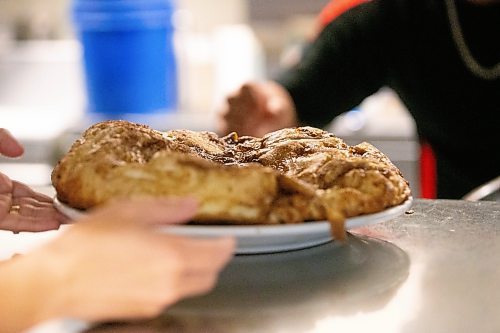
[{"left": 445, "top": 0, "right": 500, "bottom": 80}]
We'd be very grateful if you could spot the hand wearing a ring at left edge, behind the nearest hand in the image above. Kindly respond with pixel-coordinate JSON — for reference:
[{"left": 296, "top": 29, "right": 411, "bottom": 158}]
[{"left": 0, "top": 128, "right": 67, "bottom": 232}]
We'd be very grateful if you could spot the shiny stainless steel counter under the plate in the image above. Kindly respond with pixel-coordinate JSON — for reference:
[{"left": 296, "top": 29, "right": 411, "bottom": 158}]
[{"left": 75, "top": 200, "right": 500, "bottom": 333}]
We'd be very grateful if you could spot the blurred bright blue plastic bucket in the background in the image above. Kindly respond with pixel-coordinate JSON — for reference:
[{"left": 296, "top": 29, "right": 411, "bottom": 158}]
[{"left": 72, "top": 0, "right": 177, "bottom": 119}]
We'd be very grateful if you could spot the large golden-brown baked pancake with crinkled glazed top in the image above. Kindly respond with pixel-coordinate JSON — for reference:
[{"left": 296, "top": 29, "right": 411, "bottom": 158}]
[{"left": 52, "top": 121, "right": 410, "bottom": 238}]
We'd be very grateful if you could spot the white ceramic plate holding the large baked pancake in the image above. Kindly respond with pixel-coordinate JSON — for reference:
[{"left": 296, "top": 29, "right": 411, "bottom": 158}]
[{"left": 54, "top": 197, "right": 413, "bottom": 254}]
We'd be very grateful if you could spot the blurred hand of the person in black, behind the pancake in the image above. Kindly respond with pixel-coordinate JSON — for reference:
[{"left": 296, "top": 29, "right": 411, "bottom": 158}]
[{"left": 219, "top": 81, "right": 297, "bottom": 137}]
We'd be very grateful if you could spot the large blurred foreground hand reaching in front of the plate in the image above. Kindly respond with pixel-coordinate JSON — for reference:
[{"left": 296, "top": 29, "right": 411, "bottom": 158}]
[{"left": 0, "top": 199, "right": 235, "bottom": 332}]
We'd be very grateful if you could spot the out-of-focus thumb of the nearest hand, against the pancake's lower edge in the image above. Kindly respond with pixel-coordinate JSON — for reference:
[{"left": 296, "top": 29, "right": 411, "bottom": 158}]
[{"left": 84, "top": 198, "right": 198, "bottom": 225}]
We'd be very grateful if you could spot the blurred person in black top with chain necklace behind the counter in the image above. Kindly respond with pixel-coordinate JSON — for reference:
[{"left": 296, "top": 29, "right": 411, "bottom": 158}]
[{"left": 220, "top": 0, "right": 500, "bottom": 199}]
